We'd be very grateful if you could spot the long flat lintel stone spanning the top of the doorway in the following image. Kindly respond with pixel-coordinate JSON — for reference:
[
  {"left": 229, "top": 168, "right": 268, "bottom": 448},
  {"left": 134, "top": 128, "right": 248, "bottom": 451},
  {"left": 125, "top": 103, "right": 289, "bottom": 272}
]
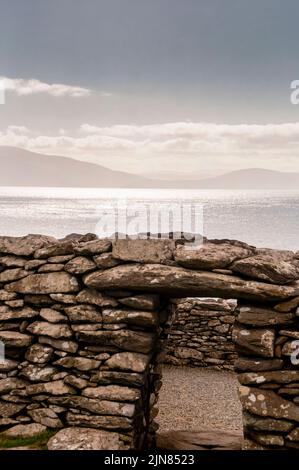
[{"left": 83, "top": 264, "right": 299, "bottom": 301}]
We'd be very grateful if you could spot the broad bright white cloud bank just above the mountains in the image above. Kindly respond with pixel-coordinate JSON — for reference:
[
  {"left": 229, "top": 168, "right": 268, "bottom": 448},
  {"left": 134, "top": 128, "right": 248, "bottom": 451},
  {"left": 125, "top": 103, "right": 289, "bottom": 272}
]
[{"left": 0, "top": 122, "right": 299, "bottom": 174}]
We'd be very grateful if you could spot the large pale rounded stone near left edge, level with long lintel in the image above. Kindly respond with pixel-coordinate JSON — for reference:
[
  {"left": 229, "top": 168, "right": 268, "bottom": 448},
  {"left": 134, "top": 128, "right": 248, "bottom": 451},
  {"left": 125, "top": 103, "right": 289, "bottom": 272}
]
[{"left": 5, "top": 272, "right": 79, "bottom": 294}]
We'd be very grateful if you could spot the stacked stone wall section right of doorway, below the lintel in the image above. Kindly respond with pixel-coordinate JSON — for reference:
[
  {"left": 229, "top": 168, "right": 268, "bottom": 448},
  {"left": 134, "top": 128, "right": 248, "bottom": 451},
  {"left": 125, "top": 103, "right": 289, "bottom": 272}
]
[{"left": 233, "top": 297, "right": 299, "bottom": 449}]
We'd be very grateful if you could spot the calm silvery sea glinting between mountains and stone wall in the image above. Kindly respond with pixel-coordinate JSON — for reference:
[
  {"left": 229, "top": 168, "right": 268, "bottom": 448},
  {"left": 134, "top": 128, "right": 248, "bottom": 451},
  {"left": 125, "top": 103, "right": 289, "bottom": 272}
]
[{"left": 0, "top": 188, "right": 299, "bottom": 250}]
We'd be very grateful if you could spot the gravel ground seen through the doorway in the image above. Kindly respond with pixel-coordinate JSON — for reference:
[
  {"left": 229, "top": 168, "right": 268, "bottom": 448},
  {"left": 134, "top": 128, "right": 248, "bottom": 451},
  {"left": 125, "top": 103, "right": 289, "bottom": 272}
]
[{"left": 156, "top": 366, "right": 242, "bottom": 432}]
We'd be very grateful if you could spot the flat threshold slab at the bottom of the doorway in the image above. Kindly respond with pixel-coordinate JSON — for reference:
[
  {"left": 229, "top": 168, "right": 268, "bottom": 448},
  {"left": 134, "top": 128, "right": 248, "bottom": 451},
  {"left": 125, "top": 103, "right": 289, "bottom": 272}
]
[{"left": 157, "top": 429, "right": 243, "bottom": 450}]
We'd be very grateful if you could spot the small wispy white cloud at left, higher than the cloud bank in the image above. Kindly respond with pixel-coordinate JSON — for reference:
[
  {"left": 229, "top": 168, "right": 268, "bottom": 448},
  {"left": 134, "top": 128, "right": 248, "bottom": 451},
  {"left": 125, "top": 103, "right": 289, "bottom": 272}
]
[{"left": 0, "top": 77, "right": 91, "bottom": 98}]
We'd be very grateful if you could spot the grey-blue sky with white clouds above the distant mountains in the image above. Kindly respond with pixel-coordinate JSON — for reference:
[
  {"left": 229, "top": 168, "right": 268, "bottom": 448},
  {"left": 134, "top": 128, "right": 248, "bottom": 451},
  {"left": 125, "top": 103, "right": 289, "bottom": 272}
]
[{"left": 0, "top": 0, "right": 299, "bottom": 178}]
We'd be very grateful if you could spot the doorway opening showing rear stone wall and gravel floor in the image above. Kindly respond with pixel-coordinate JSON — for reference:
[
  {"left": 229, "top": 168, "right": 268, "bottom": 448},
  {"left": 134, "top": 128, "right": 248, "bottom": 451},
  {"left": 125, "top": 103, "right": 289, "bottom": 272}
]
[{"left": 156, "top": 297, "right": 243, "bottom": 450}]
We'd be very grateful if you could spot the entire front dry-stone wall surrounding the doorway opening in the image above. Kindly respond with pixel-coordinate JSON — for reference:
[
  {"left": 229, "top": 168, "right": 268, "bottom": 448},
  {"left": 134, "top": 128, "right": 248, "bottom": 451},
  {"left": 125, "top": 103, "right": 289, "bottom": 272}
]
[{"left": 0, "top": 234, "right": 299, "bottom": 449}]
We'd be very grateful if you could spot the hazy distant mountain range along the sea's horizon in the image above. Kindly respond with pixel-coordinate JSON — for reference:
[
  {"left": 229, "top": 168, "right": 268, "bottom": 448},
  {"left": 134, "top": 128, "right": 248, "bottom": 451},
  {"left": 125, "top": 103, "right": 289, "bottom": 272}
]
[{"left": 0, "top": 146, "right": 299, "bottom": 189}]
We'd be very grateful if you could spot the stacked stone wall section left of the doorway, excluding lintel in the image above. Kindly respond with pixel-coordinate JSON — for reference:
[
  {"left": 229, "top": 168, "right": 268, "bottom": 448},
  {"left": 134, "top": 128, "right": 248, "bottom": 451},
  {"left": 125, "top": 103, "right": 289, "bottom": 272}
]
[{"left": 0, "top": 235, "right": 169, "bottom": 449}]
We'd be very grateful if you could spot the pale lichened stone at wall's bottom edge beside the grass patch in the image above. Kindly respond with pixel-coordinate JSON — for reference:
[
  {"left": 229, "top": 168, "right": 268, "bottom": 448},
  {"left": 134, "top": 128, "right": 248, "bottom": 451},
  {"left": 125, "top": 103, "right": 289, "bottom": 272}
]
[{"left": 48, "top": 427, "right": 127, "bottom": 450}]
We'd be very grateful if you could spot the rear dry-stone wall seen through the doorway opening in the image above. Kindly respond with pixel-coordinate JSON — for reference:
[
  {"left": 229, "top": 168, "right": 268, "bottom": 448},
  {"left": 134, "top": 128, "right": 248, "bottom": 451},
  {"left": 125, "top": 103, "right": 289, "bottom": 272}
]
[{"left": 165, "top": 297, "right": 237, "bottom": 370}]
